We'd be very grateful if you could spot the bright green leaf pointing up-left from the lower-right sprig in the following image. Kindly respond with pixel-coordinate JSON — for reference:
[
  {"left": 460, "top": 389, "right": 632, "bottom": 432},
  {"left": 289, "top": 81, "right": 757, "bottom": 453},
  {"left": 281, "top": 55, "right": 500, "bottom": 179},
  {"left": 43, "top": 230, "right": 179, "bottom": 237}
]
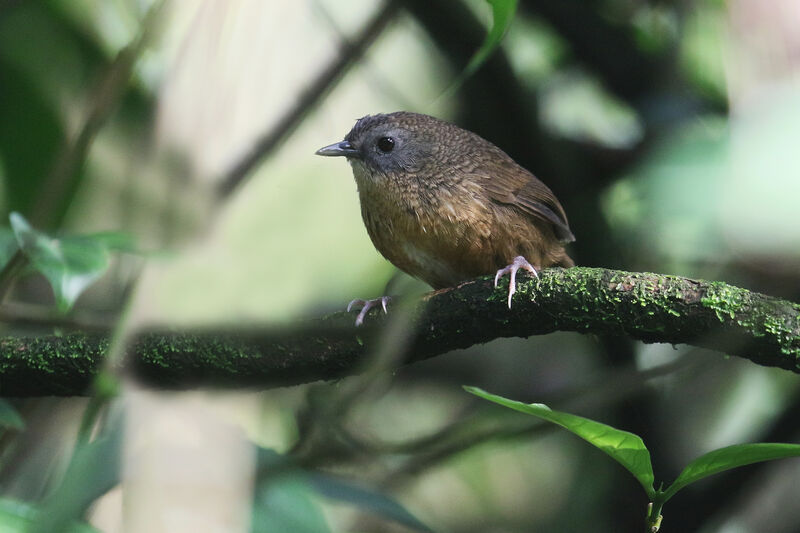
[{"left": 464, "top": 387, "right": 655, "bottom": 501}]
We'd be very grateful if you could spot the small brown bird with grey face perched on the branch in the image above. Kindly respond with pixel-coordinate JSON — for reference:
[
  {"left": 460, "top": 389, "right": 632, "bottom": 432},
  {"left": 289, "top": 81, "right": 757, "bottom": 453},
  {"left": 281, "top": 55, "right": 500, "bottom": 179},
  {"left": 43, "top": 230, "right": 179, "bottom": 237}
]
[{"left": 317, "top": 111, "right": 575, "bottom": 324}]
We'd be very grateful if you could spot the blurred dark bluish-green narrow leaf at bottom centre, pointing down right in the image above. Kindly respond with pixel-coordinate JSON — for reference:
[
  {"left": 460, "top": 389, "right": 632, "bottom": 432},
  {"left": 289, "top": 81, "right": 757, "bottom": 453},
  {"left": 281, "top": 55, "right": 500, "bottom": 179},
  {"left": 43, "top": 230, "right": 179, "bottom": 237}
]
[{"left": 311, "top": 474, "right": 432, "bottom": 533}]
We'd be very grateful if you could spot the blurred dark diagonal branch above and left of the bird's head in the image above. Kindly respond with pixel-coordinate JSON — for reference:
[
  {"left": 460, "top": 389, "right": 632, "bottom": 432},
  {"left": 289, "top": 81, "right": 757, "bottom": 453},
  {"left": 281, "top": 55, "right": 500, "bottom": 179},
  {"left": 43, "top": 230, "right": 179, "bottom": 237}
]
[{"left": 219, "top": 1, "right": 399, "bottom": 197}]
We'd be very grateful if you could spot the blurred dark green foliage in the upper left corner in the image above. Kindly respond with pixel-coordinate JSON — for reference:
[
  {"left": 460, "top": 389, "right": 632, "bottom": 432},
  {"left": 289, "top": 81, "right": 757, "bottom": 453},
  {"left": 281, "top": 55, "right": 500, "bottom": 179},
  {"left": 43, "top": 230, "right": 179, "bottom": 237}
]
[{"left": 0, "top": 2, "right": 103, "bottom": 220}]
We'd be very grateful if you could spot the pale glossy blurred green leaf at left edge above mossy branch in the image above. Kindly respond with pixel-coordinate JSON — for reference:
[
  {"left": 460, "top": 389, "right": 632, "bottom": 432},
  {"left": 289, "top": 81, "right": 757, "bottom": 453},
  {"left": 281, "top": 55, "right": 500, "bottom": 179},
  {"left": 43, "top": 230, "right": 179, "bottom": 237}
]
[{"left": 9, "top": 213, "right": 109, "bottom": 312}]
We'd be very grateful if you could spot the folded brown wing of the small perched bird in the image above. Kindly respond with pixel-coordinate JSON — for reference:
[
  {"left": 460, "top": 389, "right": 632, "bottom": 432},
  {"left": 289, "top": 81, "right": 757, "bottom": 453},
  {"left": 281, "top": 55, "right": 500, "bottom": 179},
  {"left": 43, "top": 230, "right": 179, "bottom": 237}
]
[{"left": 481, "top": 161, "right": 575, "bottom": 242}]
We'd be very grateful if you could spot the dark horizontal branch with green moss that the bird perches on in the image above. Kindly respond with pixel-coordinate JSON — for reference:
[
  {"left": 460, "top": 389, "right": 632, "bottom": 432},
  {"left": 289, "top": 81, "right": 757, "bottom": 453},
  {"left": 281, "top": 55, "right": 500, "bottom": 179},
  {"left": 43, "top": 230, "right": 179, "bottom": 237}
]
[{"left": 0, "top": 267, "right": 800, "bottom": 396}]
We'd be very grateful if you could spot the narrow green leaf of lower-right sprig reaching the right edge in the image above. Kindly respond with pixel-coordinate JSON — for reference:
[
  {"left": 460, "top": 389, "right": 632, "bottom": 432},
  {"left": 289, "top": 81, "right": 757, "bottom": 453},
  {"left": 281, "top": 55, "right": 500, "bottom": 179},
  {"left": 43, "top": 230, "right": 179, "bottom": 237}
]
[{"left": 663, "top": 442, "right": 800, "bottom": 501}]
